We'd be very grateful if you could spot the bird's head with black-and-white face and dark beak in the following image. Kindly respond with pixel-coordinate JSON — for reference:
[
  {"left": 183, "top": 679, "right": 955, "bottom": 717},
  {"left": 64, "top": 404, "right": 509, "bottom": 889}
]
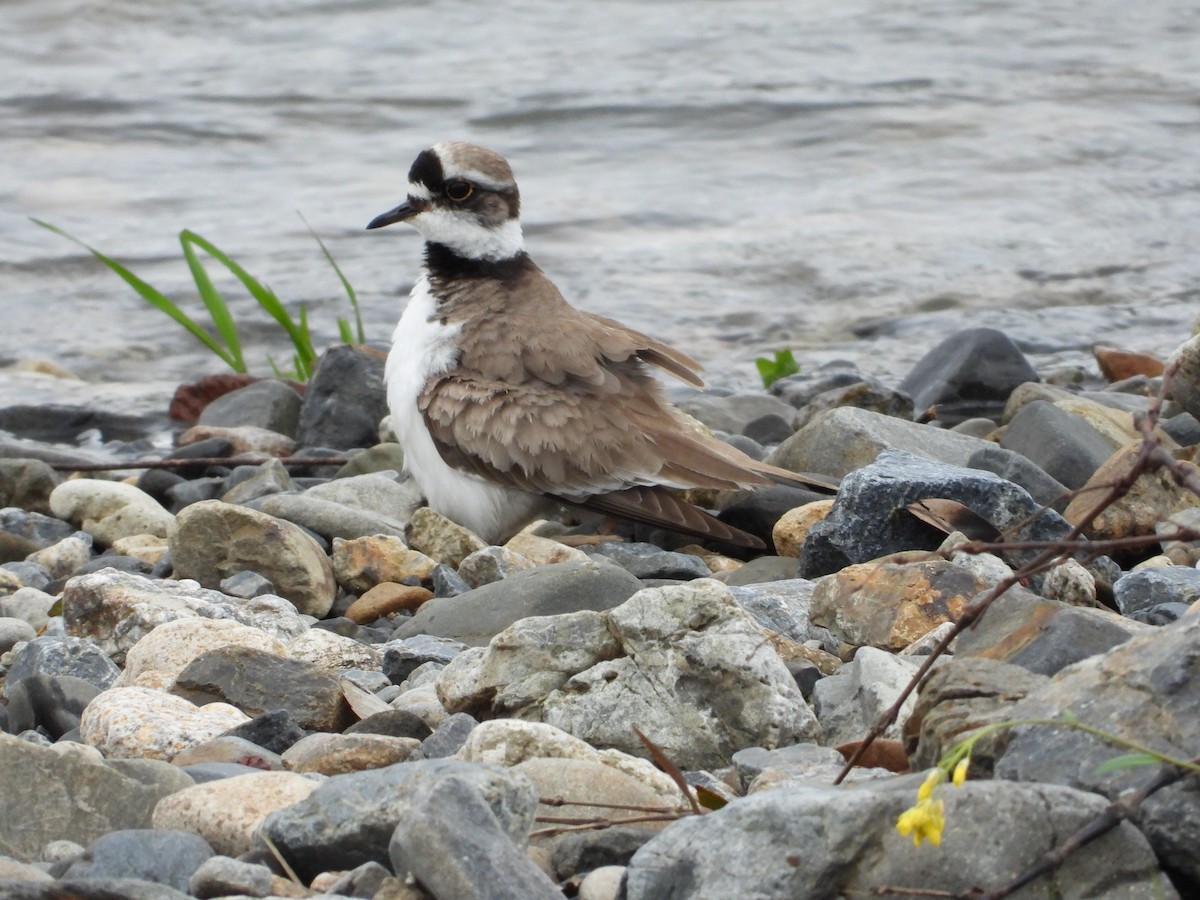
[{"left": 367, "top": 142, "right": 524, "bottom": 260}]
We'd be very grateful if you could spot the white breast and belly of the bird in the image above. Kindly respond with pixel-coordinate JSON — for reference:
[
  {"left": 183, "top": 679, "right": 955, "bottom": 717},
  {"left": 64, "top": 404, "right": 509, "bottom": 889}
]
[{"left": 384, "top": 276, "right": 544, "bottom": 542}]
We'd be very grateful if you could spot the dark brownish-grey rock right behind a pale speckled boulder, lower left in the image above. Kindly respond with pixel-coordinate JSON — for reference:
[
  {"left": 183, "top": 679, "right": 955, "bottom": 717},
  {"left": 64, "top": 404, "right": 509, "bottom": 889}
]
[{"left": 172, "top": 646, "right": 355, "bottom": 732}]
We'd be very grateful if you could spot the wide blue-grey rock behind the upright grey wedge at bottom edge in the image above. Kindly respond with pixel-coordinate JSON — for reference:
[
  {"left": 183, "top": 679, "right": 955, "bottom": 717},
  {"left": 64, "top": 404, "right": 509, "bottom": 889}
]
[{"left": 263, "top": 760, "right": 540, "bottom": 883}]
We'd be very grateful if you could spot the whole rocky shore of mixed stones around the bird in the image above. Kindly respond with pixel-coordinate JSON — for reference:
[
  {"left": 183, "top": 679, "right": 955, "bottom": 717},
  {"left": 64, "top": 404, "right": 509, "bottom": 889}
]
[{"left": 0, "top": 329, "right": 1200, "bottom": 900}]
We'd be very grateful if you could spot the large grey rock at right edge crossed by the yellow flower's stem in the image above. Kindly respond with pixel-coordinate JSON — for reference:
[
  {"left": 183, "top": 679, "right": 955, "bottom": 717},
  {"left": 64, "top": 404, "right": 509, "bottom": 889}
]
[{"left": 996, "top": 616, "right": 1200, "bottom": 894}]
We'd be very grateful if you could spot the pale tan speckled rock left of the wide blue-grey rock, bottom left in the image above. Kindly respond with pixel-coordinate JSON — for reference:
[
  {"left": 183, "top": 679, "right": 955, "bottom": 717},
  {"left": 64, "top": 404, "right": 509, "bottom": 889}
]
[{"left": 152, "top": 772, "right": 320, "bottom": 857}]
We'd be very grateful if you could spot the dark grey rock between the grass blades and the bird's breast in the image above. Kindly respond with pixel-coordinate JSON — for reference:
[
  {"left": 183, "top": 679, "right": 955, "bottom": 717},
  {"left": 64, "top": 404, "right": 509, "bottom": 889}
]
[{"left": 295, "top": 344, "right": 388, "bottom": 450}]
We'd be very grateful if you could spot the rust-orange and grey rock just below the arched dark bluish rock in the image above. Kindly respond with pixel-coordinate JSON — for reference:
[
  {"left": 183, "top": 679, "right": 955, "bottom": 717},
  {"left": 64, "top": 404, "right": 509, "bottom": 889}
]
[{"left": 810, "top": 559, "right": 986, "bottom": 652}]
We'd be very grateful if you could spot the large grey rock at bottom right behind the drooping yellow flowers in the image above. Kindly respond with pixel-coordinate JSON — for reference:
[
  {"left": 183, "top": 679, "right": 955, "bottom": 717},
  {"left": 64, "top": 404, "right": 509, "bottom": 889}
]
[{"left": 625, "top": 776, "right": 1176, "bottom": 900}]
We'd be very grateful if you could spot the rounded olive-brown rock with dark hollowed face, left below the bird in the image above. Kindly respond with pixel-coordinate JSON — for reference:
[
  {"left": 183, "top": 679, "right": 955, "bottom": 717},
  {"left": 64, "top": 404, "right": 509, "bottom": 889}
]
[{"left": 169, "top": 498, "right": 337, "bottom": 619}]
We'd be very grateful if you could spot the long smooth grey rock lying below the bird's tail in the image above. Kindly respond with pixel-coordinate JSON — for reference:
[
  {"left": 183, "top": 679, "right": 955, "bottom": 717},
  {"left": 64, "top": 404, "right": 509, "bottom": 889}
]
[{"left": 394, "top": 558, "right": 642, "bottom": 646}]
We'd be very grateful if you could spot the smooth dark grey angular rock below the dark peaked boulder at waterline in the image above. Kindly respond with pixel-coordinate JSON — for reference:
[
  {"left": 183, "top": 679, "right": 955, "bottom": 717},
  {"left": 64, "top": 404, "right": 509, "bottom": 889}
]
[{"left": 1000, "top": 400, "right": 1114, "bottom": 490}]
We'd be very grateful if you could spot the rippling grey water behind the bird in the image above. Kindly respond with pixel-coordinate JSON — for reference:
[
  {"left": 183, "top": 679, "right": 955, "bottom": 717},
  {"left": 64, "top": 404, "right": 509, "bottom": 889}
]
[{"left": 0, "top": 0, "right": 1200, "bottom": 412}]
